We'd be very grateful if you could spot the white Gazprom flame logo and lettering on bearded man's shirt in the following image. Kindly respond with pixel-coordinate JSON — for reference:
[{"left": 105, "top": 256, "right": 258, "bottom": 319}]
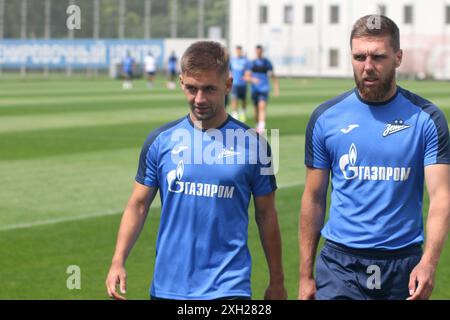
[{"left": 339, "top": 143, "right": 411, "bottom": 181}]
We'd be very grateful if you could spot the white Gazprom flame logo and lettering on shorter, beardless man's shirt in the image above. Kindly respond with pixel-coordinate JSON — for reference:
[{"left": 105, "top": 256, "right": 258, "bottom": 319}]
[{"left": 167, "top": 160, "right": 234, "bottom": 199}]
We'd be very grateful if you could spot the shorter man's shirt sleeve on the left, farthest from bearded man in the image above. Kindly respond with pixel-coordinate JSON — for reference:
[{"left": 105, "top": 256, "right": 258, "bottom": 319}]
[{"left": 135, "top": 135, "right": 159, "bottom": 187}]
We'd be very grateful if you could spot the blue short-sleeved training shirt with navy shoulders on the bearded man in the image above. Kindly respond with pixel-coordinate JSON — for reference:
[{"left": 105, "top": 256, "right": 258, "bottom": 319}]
[{"left": 305, "top": 87, "right": 450, "bottom": 249}]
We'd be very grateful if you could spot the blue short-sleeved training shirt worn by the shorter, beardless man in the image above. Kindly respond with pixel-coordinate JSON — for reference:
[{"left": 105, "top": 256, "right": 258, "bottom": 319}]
[{"left": 136, "top": 116, "right": 276, "bottom": 299}]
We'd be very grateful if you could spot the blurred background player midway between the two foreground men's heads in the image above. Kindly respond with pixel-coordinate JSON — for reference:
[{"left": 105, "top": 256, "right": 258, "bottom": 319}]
[{"left": 245, "top": 45, "right": 279, "bottom": 133}]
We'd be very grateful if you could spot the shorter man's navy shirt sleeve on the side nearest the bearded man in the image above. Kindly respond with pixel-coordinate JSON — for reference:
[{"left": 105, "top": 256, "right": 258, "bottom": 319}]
[{"left": 251, "top": 136, "right": 277, "bottom": 197}]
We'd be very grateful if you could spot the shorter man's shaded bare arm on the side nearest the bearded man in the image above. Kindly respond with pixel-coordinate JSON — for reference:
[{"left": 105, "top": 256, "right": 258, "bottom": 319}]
[{"left": 254, "top": 192, "right": 287, "bottom": 300}]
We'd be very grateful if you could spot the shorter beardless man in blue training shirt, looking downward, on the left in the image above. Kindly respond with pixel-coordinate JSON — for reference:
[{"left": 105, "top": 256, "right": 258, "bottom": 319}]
[{"left": 106, "top": 41, "right": 286, "bottom": 299}]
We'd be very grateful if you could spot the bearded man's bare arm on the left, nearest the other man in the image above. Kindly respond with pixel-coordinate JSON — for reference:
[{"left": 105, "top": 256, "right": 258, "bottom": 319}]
[{"left": 298, "top": 167, "right": 330, "bottom": 300}]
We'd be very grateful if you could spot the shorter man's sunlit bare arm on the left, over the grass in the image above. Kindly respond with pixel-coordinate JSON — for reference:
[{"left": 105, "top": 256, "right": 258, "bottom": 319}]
[{"left": 106, "top": 182, "right": 158, "bottom": 300}]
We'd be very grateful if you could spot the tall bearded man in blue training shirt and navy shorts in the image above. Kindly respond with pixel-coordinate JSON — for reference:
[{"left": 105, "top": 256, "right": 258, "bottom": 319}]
[{"left": 299, "top": 15, "right": 450, "bottom": 300}]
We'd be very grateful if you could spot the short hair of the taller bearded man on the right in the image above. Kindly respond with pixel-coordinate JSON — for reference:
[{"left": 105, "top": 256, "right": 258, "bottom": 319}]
[{"left": 350, "top": 14, "right": 400, "bottom": 52}]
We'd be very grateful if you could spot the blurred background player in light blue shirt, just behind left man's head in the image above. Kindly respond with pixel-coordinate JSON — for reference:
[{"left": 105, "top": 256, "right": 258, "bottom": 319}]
[{"left": 230, "top": 46, "right": 249, "bottom": 122}]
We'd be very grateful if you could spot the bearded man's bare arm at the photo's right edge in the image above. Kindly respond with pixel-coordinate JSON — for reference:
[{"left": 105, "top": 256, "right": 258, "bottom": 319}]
[{"left": 408, "top": 164, "right": 450, "bottom": 300}]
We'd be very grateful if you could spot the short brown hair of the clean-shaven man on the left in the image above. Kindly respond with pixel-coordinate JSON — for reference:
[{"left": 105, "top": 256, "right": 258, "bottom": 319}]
[{"left": 181, "top": 41, "right": 230, "bottom": 75}]
